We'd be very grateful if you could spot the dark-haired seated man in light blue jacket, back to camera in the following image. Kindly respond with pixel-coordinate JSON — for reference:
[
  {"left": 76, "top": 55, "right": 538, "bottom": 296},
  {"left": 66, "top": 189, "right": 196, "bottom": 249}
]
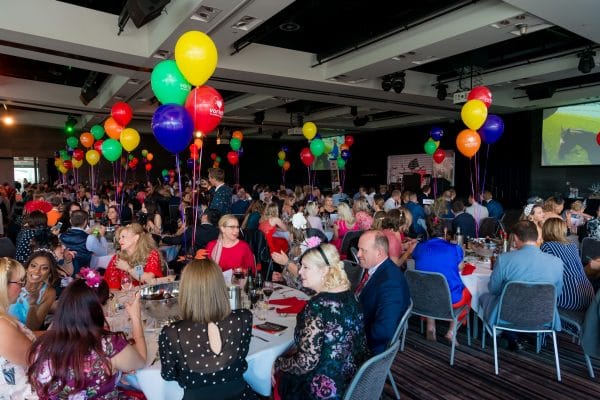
[{"left": 479, "top": 220, "right": 563, "bottom": 348}]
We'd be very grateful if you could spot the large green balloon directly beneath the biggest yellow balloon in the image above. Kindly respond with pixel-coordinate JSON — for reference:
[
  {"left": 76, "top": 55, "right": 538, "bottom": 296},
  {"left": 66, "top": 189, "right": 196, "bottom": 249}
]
[{"left": 150, "top": 60, "right": 192, "bottom": 106}]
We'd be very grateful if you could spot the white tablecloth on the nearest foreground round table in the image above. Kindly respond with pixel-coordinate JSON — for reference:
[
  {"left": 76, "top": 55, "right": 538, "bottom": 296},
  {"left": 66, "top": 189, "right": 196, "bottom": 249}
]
[{"left": 136, "top": 285, "right": 307, "bottom": 400}]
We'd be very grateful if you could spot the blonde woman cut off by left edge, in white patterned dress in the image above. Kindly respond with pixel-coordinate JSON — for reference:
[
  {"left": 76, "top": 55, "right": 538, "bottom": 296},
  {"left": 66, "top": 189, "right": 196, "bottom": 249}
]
[{"left": 0, "top": 257, "right": 37, "bottom": 399}]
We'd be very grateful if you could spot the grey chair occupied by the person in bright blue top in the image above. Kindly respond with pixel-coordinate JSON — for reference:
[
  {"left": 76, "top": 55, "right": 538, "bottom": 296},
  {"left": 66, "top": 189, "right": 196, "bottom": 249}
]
[{"left": 405, "top": 270, "right": 471, "bottom": 365}]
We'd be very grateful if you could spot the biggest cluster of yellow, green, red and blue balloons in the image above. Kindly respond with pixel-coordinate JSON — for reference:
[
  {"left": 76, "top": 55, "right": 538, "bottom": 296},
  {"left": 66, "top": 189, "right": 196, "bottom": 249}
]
[{"left": 150, "top": 31, "right": 224, "bottom": 154}]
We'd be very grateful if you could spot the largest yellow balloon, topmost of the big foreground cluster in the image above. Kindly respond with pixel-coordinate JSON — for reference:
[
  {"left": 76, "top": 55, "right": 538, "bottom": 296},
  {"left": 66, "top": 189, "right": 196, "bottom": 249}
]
[{"left": 175, "top": 31, "right": 218, "bottom": 86}]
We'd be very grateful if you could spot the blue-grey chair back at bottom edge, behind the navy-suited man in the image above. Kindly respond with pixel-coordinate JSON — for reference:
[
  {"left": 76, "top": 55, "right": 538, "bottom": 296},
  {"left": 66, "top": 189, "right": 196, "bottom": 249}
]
[{"left": 344, "top": 341, "right": 400, "bottom": 400}]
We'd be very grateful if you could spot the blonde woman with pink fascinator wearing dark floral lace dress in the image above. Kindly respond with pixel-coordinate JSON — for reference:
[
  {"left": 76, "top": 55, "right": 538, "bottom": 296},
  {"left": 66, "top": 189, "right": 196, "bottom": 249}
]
[{"left": 274, "top": 244, "right": 369, "bottom": 400}]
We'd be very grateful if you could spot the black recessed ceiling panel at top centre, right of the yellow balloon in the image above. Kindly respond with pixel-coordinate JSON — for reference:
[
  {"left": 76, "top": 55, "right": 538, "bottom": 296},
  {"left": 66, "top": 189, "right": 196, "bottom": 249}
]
[{"left": 234, "top": 0, "right": 474, "bottom": 60}]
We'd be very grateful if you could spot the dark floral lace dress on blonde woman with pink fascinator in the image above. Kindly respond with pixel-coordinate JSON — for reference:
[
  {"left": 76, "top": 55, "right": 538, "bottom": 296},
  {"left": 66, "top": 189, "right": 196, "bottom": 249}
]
[{"left": 275, "top": 290, "right": 369, "bottom": 400}]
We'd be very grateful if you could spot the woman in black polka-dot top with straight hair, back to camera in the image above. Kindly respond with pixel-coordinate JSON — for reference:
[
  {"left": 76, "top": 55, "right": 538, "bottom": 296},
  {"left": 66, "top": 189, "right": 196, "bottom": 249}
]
[{"left": 158, "top": 259, "right": 256, "bottom": 400}]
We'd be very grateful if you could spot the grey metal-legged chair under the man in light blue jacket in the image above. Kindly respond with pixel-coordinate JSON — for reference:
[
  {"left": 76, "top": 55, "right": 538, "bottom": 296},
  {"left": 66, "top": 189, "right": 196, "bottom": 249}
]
[{"left": 483, "top": 281, "right": 561, "bottom": 382}]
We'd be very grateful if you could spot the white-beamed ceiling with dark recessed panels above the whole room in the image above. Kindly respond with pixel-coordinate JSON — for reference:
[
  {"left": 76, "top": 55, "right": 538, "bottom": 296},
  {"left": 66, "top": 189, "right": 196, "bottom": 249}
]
[{"left": 0, "top": 0, "right": 600, "bottom": 142}]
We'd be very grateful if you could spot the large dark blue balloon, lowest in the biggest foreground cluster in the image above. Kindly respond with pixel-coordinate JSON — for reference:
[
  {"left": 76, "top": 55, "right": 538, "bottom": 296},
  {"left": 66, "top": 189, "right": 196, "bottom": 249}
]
[{"left": 152, "top": 104, "right": 194, "bottom": 153}]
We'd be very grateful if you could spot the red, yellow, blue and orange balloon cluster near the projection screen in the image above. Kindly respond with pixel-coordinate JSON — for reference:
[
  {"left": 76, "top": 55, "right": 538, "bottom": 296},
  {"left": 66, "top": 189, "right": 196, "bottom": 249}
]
[{"left": 456, "top": 86, "right": 504, "bottom": 158}]
